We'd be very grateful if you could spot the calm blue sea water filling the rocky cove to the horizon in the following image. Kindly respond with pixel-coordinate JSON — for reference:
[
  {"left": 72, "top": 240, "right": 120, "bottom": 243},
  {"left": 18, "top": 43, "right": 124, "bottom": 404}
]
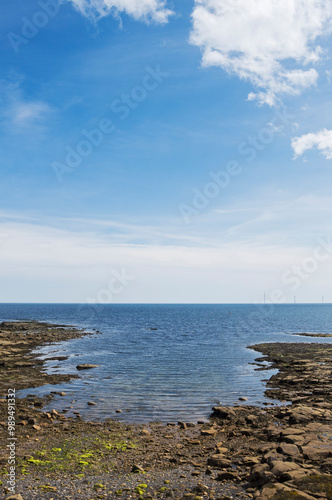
[{"left": 0, "top": 304, "right": 332, "bottom": 422}]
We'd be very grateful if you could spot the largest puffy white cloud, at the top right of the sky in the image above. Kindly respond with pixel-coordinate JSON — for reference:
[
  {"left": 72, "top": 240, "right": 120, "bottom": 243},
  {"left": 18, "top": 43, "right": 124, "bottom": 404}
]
[{"left": 190, "top": 0, "right": 332, "bottom": 105}]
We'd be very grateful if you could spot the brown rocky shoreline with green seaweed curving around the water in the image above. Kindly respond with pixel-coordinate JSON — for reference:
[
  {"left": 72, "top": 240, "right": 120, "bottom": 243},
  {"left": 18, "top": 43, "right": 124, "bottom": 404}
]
[{"left": 0, "top": 322, "right": 332, "bottom": 500}]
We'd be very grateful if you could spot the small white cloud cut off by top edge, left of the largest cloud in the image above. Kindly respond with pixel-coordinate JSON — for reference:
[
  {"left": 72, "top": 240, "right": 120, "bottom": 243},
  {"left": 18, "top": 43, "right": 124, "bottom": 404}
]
[{"left": 66, "top": 0, "right": 172, "bottom": 23}]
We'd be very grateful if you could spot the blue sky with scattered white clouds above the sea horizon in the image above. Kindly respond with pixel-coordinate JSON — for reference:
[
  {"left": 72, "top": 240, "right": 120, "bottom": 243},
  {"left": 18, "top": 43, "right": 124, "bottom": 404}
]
[{"left": 0, "top": 0, "right": 332, "bottom": 303}]
